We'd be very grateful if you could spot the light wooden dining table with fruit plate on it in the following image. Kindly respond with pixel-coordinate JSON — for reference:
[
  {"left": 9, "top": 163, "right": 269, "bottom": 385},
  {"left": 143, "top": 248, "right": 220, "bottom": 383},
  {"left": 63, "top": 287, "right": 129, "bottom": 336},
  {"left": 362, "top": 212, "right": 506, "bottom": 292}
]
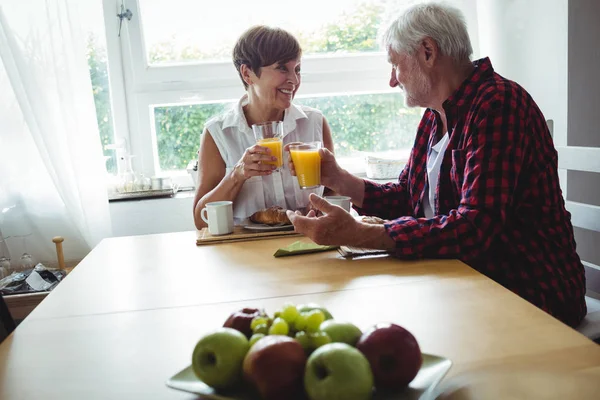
[{"left": 0, "top": 232, "right": 600, "bottom": 400}]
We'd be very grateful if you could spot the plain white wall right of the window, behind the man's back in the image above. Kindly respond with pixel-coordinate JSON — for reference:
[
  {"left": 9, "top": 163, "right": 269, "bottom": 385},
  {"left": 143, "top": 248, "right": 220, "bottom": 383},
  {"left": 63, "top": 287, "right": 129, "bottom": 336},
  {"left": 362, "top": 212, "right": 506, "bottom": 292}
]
[{"left": 477, "top": 0, "right": 568, "bottom": 146}]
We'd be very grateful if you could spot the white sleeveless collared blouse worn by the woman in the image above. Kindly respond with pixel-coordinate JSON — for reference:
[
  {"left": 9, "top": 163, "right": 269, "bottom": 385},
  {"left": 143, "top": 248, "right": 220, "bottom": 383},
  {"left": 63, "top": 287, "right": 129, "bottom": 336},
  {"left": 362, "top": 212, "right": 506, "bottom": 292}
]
[{"left": 205, "top": 95, "right": 323, "bottom": 224}]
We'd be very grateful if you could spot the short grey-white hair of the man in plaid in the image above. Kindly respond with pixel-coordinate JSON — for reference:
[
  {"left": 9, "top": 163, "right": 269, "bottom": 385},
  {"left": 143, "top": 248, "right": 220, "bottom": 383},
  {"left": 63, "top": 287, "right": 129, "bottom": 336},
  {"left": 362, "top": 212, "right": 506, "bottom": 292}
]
[{"left": 381, "top": 3, "right": 473, "bottom": 62}]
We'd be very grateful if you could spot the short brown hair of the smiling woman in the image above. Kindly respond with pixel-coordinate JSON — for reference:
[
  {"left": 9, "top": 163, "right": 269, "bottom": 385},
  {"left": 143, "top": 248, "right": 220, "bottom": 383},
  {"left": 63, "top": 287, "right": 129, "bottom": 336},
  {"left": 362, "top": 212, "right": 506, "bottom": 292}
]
[{"left": 233, "top": 25, "right": 302, "bottom": 88}]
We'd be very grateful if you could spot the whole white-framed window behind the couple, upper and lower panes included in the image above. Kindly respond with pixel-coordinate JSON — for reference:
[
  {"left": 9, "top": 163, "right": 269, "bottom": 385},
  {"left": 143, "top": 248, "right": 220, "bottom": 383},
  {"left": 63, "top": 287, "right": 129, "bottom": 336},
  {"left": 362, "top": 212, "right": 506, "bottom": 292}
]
[{"left": 103, "top": 0, "right": 476, "bottom": 186}]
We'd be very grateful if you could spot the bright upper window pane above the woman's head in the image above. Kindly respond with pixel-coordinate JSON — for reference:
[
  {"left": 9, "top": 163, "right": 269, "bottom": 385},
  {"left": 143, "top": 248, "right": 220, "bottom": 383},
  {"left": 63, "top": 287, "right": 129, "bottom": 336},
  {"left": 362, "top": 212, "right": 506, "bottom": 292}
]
[{"left": 139, "top": 0, "right": 387, "bottom": 65}]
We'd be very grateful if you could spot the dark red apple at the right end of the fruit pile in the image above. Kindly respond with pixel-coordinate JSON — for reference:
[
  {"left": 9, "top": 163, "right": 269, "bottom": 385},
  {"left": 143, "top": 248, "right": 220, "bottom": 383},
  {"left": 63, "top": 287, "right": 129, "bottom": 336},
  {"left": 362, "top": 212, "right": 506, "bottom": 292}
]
[{"left": 356, "top": 323, "right": 423, "bottom": 389}]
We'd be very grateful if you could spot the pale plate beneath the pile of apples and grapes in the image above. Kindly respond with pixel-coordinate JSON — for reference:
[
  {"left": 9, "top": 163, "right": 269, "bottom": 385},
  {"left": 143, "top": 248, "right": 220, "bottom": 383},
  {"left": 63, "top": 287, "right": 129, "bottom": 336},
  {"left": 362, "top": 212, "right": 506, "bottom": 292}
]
[{"left": 166, "top": 353, "right": 452, "bottom": 400}]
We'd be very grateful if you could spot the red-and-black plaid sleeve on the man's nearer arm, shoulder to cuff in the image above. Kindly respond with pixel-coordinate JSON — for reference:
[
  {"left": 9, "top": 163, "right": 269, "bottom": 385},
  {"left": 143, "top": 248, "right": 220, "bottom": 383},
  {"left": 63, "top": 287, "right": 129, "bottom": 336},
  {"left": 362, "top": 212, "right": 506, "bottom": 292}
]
[{"left": 384, "top": 100, "right": 529, "bottom": 258}]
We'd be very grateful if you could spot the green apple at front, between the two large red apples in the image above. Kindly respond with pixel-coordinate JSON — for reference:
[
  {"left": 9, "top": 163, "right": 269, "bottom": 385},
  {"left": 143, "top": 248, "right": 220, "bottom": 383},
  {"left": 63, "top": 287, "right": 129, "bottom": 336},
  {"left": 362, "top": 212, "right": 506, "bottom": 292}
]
[{"left": 304, "top": 343, "right": 373, "bottom": 400}]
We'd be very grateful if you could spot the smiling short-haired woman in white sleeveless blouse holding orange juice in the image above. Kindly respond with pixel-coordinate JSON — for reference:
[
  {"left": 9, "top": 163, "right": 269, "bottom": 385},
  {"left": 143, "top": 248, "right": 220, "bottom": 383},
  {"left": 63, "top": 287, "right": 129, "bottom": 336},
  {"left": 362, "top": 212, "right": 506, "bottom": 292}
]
[{"left": 194, "top": 26, "right": 333, "bottom": 229}]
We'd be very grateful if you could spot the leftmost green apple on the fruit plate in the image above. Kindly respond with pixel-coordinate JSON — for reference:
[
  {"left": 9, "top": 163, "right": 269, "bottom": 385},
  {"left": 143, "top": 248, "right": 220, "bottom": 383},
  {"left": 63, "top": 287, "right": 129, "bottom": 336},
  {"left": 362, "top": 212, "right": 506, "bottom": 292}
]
[{"left": 192, "top": 328, "right": 250, "bottom": 389}]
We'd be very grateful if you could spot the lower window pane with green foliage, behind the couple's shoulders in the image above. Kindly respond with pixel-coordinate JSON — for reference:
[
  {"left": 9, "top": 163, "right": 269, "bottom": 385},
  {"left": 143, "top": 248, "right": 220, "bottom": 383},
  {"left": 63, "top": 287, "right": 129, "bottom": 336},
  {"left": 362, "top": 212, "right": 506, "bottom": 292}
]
[{"left": 154, "top": 93, "right": 422, "bottom": 171}]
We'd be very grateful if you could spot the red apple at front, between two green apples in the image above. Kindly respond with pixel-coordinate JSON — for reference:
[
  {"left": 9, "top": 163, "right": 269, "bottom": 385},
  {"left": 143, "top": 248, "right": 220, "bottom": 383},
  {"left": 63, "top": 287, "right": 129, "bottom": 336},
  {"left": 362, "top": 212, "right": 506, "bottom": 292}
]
[{"left": 243, "top": 335, "right": 306, "bottom": 400}]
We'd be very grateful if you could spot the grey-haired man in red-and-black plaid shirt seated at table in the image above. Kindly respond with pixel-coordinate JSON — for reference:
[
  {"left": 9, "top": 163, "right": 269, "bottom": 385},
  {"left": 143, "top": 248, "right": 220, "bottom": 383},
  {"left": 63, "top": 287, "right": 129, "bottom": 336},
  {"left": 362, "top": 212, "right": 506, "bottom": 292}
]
[{"left": 288, "top": 4, "right": 586, "bottom": 326}]
